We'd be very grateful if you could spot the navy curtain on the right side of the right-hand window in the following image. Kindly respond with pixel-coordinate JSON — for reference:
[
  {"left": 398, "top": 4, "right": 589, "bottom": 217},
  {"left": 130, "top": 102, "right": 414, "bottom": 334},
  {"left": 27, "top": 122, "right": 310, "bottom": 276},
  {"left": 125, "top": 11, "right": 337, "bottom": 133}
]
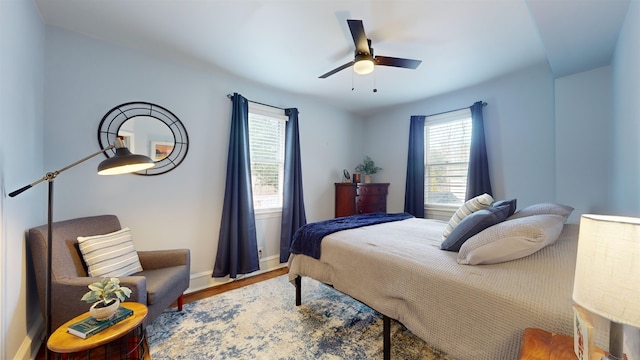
[{"left": 466, "top": 101, "right": 493, "bottom": 200}]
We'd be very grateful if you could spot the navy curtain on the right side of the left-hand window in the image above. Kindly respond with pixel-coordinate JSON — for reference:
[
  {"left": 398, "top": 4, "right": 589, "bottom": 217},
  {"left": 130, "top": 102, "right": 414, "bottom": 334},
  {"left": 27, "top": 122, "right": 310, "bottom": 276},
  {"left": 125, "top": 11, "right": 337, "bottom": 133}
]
[{"left": 280, "top": 108, "right": 307, "bottom": 263}]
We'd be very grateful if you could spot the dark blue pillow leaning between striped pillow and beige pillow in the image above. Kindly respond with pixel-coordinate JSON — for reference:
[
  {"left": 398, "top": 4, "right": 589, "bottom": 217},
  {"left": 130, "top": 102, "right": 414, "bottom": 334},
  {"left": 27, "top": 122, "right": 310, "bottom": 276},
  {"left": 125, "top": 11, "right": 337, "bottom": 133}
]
[{"left": 440, "top": 204, "right": 510, "bottom": 251}]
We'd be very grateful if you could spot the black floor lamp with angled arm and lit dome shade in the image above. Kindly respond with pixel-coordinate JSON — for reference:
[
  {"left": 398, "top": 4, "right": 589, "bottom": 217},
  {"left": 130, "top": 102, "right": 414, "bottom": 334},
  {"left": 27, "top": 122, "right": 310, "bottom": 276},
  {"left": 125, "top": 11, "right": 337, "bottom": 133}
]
[{"left": 9, "top": 138, "right": 155, "bottom": 360}]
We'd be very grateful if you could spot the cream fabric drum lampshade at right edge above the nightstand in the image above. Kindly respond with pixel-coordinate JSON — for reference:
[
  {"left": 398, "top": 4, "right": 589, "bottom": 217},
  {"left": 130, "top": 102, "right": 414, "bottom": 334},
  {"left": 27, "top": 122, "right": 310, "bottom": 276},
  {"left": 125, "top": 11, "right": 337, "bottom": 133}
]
[{"left": 573, "top": 214, "right": 640, "bottom": 327}]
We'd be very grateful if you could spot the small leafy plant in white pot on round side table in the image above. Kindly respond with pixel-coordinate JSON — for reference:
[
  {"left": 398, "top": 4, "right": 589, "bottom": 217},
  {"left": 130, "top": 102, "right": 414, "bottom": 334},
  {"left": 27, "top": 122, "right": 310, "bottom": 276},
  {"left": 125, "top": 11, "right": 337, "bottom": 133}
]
[{"left": 81, "top": 277, "right": 131, "bottom": 321}]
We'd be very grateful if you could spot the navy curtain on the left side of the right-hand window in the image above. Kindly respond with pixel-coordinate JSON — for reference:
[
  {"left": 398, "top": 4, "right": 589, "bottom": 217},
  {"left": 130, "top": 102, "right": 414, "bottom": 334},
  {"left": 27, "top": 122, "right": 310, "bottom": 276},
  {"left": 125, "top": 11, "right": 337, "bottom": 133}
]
[{"left": 404, "top": 115, "right": 426, "bottom": 218}]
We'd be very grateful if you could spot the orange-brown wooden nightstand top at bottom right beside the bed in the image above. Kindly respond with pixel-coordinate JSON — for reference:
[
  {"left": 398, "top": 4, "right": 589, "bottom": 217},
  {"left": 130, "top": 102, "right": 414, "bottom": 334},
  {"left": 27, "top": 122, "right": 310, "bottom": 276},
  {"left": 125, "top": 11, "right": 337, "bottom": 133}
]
[{"left": 518, "top": 328, "right": 605, "bottom": 360}]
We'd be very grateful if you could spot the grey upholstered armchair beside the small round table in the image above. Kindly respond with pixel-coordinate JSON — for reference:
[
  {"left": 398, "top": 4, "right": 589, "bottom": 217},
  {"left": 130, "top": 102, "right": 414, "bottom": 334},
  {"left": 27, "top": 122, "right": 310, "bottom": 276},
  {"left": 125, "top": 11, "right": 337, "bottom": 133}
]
[{"left": 27, "top": 215, "right": 191, "bottom": 329}]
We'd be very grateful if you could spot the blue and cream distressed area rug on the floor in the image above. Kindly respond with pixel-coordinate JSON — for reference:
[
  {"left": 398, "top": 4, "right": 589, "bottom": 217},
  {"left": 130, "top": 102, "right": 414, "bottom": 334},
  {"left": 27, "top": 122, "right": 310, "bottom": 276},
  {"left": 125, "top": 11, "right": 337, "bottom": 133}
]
[{"left": 147, "top": 275, "right": 452, "bottom": 360}]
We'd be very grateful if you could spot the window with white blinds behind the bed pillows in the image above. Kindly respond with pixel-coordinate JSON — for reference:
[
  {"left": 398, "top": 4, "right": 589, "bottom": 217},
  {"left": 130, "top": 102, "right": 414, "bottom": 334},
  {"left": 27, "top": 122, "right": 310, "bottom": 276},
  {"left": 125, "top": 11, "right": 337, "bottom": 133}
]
[{"left": 424, "top": 109, "right": 471, "bottom": 206}]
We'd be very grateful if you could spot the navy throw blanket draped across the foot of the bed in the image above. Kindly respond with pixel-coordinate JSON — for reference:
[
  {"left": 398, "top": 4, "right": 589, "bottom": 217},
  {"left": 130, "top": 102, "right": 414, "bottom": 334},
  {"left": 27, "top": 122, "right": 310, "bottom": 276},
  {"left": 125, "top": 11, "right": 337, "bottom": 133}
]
[{"left": 291, "top": 212, "right": 414, "bottom": 259}]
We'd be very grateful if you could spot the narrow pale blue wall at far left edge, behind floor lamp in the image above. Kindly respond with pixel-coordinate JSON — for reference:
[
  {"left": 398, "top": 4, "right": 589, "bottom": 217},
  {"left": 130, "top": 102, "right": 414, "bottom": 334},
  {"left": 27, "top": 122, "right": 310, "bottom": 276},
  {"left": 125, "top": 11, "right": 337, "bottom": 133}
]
[{"left": 0, "top": 0, "right": 47, "bottom": 359}]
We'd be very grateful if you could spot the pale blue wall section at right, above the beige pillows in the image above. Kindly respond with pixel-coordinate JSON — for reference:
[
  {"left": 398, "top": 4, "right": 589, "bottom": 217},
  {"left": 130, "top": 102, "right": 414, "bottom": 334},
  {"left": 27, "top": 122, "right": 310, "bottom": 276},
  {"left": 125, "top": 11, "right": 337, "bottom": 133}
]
[{"left": 555, "top": 66, "right": 614, "bottom": 222}]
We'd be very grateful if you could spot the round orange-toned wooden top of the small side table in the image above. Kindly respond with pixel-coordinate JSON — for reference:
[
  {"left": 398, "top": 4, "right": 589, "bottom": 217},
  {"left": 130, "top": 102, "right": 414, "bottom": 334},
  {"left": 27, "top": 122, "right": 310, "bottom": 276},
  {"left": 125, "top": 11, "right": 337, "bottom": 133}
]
[{"left": 47, "top": 302, "right": 147, "bottom": 354}]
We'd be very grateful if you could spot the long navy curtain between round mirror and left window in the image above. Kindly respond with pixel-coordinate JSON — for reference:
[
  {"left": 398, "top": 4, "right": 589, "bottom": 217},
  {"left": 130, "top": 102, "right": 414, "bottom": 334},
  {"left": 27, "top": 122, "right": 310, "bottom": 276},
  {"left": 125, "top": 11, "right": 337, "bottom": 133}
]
[{"left": 213, "top": 93, "right": 260, "bottom": 279}]
